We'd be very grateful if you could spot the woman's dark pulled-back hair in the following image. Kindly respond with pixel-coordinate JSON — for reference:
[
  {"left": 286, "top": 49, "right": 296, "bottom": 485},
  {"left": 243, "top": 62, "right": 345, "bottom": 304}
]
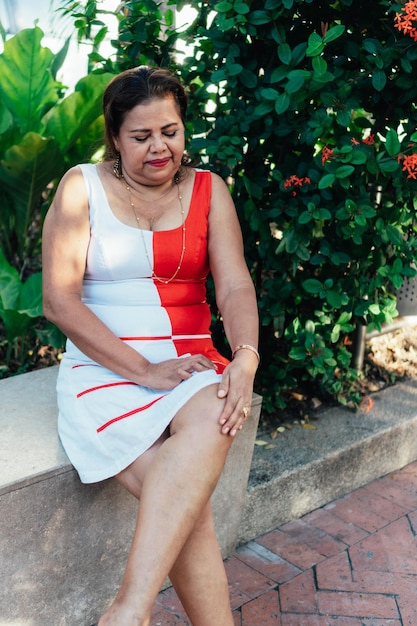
[{"left": 103, "top": 65, "right": 188, "bottom": 159}]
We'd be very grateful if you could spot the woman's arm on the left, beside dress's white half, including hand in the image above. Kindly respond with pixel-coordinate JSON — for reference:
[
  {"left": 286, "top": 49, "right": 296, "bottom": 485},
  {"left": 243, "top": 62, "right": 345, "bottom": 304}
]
[{"left": 42, "top": 167, "right": 213, "bottom": 389}]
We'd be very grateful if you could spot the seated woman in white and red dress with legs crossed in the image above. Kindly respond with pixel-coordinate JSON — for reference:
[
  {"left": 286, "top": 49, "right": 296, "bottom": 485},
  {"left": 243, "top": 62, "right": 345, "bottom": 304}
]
[{"left": 43, "top": 67, "right": 259, "bottom": 626}]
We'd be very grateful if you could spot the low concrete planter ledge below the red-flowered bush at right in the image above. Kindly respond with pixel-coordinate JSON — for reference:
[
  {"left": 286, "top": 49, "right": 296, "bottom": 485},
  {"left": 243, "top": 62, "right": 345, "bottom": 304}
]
[{"left": 238, "top": 380, "right": 417, "bottom": 544}]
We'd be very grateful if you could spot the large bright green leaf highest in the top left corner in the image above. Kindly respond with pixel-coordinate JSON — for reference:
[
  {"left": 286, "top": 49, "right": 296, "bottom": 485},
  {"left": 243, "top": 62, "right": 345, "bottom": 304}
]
[{"left": 0, "top": 27, "right": 59, "bottom": 134}]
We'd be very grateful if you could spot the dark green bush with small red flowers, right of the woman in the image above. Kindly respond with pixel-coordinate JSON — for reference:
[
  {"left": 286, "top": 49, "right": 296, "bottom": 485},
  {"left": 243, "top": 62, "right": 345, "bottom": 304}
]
[{"left": 4, "top": 0, "right": 417, "bottom": 411}]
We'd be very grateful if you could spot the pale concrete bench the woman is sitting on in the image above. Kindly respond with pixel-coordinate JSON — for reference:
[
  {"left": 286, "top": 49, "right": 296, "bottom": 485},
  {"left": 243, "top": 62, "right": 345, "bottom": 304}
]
[{"left": 0, "top": 367, "right": 261, "bottom": 626}]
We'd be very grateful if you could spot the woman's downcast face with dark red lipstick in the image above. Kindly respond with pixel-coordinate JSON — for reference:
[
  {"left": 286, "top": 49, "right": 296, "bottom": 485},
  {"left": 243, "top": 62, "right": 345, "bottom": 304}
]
[{"left": 114, "top": 96, "right": 185, "bottom": 186}]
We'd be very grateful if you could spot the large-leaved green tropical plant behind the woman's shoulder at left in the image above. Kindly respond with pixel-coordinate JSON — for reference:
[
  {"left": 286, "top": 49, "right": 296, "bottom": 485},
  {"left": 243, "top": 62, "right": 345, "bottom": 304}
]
[{"left": 0, "top": 27, "right": 110, "bottom": 376}]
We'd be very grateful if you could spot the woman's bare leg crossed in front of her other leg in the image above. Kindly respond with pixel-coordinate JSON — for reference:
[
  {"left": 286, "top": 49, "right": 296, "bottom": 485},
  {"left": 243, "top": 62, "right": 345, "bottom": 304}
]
[{"left": 99, "top": 385, "right": 233, "bottom": 626}]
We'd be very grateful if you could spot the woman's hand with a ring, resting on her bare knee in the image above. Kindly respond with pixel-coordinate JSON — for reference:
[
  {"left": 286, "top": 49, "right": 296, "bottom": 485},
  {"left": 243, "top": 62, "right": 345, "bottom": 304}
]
[{"left": 217, "top": 350, "right": 258, "bottom": 437}]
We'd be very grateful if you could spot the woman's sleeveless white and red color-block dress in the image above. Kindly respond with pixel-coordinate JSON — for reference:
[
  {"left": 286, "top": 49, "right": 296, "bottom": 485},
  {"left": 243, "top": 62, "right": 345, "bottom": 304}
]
[{"left": 57, "top": 164, "right": 228, "bottom": 483}]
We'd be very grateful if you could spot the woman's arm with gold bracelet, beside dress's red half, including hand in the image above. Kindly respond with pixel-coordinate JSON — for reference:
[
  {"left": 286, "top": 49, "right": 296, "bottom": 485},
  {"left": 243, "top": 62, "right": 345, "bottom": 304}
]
[{"left": 208, "top": 174, "right": 259, "bottom": 436}]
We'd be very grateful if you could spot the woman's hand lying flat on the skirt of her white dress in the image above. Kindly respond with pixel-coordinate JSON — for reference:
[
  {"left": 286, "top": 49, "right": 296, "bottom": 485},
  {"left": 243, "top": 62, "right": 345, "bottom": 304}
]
[{"left": 139, "top": 354, "right": 216, "bottom": 389}]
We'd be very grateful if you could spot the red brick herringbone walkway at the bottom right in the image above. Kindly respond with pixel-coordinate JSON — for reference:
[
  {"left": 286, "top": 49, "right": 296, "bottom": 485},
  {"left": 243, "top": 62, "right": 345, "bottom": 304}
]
[{"left": 152, "top": 462, "right": 417, "bottom": 626}]
